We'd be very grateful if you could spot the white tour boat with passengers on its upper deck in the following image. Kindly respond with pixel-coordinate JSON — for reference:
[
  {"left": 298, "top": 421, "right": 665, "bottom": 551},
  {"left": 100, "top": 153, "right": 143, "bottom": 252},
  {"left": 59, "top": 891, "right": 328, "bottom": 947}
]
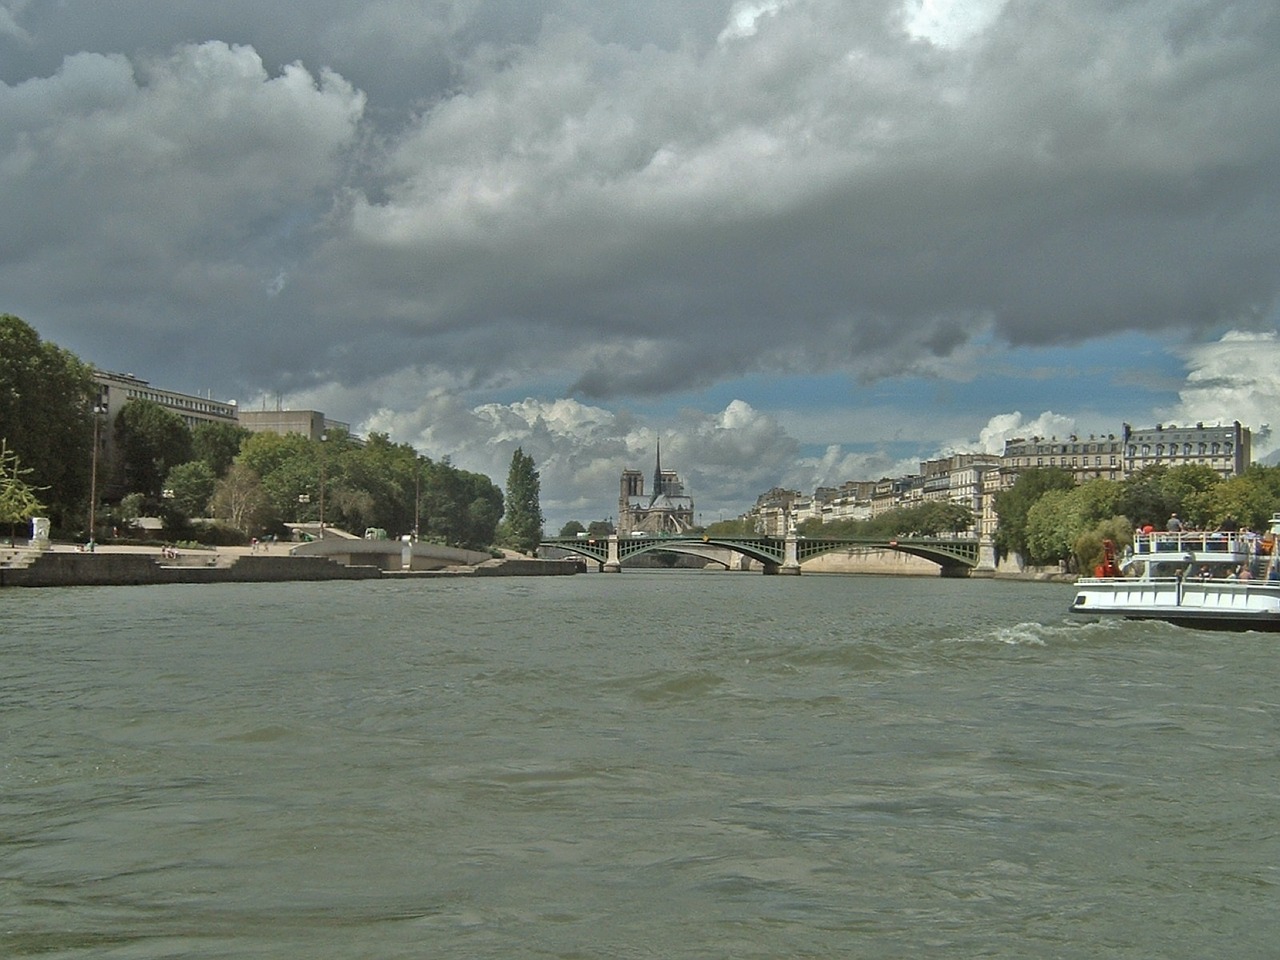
[{"left": 1071, "top": 513, "right": 1280, "bottom": 630}]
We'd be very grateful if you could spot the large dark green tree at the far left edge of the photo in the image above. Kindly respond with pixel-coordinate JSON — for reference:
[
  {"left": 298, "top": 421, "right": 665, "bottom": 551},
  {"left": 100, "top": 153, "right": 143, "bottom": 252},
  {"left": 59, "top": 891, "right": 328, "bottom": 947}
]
[{"left": 0, "top": 314, "right": 95, "bottom": 527}]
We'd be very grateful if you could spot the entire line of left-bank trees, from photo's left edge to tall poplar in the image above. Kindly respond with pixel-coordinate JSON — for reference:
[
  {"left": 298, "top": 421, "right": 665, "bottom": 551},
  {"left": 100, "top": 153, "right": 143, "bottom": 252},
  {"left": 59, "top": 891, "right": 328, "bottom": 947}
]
[{"left": 0, "top": 315, "right": 543, "bottom": 552}]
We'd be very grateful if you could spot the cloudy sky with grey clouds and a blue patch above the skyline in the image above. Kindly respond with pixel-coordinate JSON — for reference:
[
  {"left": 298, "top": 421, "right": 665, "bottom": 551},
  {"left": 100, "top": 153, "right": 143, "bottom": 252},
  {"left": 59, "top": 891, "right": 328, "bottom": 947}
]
[{"left": 0, "top": 0, "right": 1280, "bottom": 529}]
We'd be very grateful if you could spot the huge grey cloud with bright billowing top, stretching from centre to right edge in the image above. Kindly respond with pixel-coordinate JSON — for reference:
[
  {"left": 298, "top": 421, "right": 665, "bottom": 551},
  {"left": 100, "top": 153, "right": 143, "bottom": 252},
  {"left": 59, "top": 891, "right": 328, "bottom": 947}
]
[{"left": 293, "top": 3, "right": 1280, "bottom": 396}]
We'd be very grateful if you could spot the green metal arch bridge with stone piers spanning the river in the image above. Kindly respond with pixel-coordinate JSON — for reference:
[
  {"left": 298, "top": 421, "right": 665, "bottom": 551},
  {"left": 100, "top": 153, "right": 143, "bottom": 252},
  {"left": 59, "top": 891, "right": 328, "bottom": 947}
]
[{"left": 541, "top": 534, "right": 996, "bottom": 577}]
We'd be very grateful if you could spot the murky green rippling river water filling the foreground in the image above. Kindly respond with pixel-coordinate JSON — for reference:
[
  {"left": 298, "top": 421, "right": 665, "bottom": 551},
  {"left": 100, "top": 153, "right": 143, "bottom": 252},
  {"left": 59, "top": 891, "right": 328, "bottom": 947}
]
[{"left": 0, "top": 571, "right": 1280, "bottom": 960}]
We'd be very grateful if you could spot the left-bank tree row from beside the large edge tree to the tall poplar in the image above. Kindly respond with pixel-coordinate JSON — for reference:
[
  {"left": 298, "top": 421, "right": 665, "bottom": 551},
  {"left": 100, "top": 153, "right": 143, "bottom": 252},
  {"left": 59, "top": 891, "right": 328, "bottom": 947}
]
[{"left": 116, "top": 399, "right": 541, "bottom": 552}]
